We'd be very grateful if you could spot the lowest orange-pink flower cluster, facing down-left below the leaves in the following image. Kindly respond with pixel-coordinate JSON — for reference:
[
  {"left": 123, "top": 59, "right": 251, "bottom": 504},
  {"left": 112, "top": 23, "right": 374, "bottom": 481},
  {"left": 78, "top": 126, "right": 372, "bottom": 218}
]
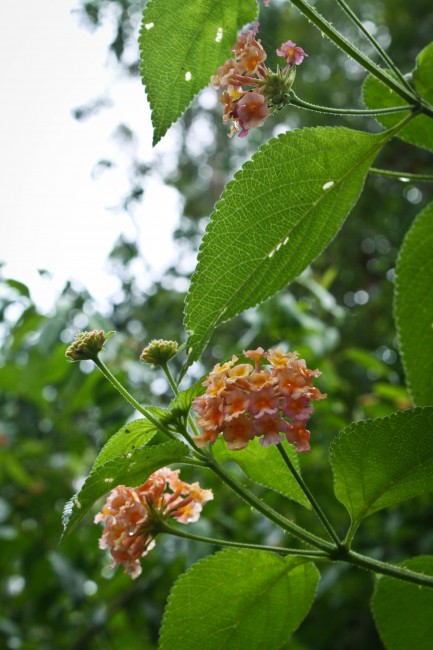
[{"left": 95, "top": 467, "right": 213, "bottom": 579}]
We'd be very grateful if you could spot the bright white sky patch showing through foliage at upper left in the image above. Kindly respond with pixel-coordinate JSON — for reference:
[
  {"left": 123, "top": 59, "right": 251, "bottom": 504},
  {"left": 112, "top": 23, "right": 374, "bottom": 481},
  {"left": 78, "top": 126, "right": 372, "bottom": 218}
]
[{"left": 0, "top": 0, "right": 179, "bottom": 308}]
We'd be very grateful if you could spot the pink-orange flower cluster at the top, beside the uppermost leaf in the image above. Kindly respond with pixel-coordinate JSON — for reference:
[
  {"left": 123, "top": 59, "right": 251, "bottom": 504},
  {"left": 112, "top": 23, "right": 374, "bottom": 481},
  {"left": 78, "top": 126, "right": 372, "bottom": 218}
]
[{"left": 211, "top": 22, "right": 308, "bottom": 138}]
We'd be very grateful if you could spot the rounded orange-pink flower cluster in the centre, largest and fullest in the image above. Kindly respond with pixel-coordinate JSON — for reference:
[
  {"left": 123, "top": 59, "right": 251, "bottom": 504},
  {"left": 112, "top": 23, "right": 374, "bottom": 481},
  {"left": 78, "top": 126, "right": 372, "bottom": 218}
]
[{"left": 193, "top": 348, "right": 326, "bottom": 451}]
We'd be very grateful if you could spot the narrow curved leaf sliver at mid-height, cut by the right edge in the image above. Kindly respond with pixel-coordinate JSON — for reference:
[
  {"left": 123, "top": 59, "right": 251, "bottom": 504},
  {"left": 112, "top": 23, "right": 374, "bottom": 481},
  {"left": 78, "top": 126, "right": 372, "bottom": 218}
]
[{"left": 394, "top": 203, "right": 433, "bottom": 406}]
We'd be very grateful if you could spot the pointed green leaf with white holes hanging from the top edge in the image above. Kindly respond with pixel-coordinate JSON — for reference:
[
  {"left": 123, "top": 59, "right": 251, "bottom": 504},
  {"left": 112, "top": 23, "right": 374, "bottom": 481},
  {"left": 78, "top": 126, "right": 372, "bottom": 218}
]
[{"left": 139, "top": 0, "right": 258, "bottom": 145}]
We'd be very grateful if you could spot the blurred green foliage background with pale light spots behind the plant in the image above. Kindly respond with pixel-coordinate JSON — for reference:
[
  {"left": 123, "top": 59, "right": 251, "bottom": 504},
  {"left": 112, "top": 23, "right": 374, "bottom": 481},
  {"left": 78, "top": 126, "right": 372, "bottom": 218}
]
[{"left": 0, "top": 0, "right": 433, "bottom": 650}]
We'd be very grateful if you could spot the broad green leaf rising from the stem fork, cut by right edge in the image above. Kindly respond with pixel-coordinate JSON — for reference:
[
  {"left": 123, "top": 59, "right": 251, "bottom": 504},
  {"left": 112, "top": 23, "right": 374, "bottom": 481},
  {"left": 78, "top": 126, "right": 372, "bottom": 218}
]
[{"left": 330, "top": 407, "right": 433, "bottom": 525}]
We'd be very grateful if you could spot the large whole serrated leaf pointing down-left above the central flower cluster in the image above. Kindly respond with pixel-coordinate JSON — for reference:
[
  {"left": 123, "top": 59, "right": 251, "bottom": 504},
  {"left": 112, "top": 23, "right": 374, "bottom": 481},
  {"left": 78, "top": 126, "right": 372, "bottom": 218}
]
[{"left": 185, "top": 127, "right": 389, "bottom": 364}]
